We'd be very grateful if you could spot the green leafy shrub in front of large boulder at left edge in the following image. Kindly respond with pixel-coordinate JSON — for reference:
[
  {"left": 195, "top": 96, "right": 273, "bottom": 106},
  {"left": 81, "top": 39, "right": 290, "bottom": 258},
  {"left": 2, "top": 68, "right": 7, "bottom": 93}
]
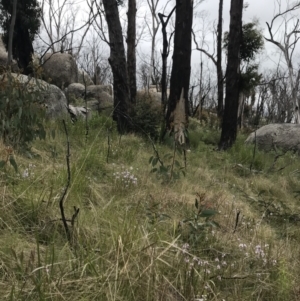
[{"left": 0, "top": 77, "right": 46, "bottom": 148}]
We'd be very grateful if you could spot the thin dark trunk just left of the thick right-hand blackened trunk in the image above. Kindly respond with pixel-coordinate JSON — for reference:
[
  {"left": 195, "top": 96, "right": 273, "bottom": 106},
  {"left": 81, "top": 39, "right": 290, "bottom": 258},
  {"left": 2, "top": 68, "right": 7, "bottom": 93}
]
[{"left": 217, "top": 0, "right": 224, "bottom": 119}]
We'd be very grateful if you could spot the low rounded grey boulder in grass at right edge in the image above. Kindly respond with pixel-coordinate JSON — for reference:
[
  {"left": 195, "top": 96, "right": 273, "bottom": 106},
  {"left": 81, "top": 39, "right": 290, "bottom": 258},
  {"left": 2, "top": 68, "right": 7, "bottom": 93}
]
[{"left": 245, "top": 123, "right": 300, "bottom": 155}]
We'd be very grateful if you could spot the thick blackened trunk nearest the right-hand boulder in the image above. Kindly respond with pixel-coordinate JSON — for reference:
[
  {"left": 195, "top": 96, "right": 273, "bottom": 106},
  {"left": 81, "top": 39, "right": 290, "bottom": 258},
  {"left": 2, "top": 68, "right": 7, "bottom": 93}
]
[{"left": 219, "top": 0, "right": 243, "bottom": 150}]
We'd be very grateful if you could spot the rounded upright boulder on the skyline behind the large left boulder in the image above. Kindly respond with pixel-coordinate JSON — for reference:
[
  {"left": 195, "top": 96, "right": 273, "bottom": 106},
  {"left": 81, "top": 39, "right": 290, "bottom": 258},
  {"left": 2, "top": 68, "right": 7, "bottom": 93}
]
[{"left": 43, "top": 53, "right": 78, "bottom": 89}]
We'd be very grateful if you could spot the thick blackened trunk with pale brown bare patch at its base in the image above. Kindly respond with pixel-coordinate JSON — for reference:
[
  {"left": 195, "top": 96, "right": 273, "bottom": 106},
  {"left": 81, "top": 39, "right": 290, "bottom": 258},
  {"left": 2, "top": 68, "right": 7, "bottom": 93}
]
[{"left": 166, "top": 0, "right": 194, "bottom": 144}]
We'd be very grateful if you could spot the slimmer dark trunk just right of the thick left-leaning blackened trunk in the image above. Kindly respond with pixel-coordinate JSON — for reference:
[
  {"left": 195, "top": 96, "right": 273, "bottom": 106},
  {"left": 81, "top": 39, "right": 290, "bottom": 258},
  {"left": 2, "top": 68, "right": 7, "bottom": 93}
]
[{"left": 126, "top": 0, "right": 136, "bottom": 104}]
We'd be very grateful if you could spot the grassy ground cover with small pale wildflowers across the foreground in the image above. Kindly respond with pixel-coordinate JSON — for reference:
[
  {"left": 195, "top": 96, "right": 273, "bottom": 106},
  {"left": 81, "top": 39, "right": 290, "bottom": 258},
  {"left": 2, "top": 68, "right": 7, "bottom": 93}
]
[{"left": 0, "top": 115, "right": 300, "bottom": 301}]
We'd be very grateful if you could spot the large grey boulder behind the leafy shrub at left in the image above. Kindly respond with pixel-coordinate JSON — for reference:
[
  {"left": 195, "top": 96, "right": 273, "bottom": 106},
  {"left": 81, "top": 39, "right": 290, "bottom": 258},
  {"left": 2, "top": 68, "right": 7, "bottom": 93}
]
[{"left": 0, "top": 73, "right": 67, "bottom": 118}]
